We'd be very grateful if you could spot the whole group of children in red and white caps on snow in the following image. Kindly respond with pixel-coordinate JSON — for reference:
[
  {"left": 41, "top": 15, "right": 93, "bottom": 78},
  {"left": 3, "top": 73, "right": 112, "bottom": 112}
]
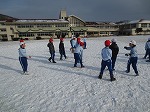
[{"left": 19, "top": 35, "right": 150, "bottom": 81}]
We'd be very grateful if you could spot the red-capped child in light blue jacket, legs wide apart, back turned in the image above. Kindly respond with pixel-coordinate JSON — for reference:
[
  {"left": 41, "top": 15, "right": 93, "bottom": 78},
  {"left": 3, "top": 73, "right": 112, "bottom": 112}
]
[{"left": 98, "top": 40, "right": 116, "bottom": 81}]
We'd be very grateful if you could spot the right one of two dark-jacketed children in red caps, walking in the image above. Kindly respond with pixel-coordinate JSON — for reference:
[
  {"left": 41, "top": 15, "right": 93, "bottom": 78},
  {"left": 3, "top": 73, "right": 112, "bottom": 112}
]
[{"left": 59, "top": 38, "right": 67, "bottom": 60}]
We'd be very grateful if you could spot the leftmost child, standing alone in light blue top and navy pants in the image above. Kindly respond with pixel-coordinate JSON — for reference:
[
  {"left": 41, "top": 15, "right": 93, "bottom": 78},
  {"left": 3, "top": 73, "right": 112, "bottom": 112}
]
[{"left": 18, "top": 41, "right": 31, "bottom": 75}]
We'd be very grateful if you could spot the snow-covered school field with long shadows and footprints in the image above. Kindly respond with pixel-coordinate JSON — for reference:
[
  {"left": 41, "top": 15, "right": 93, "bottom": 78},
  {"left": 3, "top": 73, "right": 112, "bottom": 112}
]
[{"left": 0, "top": 36, "right": 150, "bottom": 112}]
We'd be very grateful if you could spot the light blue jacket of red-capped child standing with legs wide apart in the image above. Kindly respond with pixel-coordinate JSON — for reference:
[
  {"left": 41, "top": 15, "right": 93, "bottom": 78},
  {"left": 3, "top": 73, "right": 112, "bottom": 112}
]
[{"left": 101, "top": 47, "right": 112, "bottom": 61}]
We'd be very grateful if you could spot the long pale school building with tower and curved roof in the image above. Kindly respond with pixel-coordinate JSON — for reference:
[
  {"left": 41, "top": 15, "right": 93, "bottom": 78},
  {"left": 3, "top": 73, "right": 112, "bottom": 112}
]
[{"left": 0, "top": 10, "right": 150, "bottom": 40}]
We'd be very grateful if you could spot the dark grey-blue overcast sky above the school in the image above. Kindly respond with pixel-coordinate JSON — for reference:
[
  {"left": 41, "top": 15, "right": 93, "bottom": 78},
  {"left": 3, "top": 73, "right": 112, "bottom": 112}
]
[{"left": 0, "top": 0, "right": 150, "bottom": 22}]
